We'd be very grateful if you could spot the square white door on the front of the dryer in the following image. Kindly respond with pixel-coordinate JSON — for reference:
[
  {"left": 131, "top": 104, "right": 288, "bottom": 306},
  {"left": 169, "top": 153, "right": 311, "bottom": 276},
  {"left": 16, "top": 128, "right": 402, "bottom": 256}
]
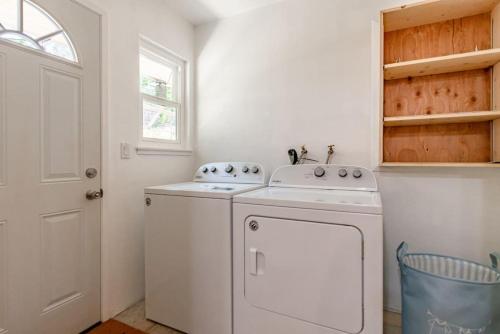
[{"left": 245, "top": 217, "right": 363, "bottom": 333}]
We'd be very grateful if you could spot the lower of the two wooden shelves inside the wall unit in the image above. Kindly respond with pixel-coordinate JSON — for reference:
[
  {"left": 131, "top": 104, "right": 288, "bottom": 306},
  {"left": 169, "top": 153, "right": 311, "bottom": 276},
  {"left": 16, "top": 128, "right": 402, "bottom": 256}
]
[{"left": 384, "top": 111, "right": 500, "bottom": 127}]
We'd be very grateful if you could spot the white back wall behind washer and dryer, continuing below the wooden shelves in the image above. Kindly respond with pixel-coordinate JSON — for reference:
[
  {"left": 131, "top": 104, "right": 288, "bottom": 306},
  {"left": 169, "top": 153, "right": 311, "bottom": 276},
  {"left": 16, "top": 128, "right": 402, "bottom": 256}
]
[{"left": 196, "top": 0, "right": 500, "bottom": 309}]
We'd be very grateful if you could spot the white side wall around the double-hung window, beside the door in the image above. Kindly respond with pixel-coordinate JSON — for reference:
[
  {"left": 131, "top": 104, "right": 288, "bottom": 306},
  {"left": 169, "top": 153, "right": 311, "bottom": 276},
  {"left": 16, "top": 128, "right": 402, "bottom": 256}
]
[{"left": 85, "top": 0, "right": 194, "bottom": 319}]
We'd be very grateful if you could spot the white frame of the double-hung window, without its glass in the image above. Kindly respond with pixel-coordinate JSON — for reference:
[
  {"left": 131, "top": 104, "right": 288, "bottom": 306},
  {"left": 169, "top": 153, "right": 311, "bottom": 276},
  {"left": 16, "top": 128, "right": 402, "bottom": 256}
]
[{"left": 137, "top": 36, "right": 191, "bottom": 155}]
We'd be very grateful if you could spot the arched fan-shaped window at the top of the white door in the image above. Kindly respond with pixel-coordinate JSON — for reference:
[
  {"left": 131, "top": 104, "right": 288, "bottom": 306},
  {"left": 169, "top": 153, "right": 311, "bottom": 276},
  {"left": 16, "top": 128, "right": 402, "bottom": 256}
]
[{"left": 0, "top": 0, "right": 78, "bottom": 62}]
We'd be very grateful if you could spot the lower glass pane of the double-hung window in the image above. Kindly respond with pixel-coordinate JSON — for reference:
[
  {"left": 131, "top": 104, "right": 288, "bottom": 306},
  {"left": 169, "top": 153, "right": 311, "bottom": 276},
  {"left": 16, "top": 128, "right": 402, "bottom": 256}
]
[{"left": 142, "top": 100, "right": 177, "bottom": 141}]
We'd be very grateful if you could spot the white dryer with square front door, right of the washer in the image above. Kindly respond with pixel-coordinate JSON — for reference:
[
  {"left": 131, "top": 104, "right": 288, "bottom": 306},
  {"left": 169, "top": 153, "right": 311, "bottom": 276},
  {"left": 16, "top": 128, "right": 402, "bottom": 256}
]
[{"left": 233, "top": 165, "right": 383, "bottom": 334}]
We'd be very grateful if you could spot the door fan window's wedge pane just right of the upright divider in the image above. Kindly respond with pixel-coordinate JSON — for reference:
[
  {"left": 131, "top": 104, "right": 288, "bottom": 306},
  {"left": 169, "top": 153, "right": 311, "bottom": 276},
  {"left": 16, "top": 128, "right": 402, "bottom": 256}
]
[{"left": 23, "top": 1, "right": 61, "bottom": 39}]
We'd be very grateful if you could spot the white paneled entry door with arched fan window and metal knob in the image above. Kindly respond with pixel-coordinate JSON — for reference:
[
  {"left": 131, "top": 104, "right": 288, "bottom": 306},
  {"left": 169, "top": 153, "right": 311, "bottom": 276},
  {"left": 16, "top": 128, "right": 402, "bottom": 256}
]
[{"left": 0, "top": 0, "right": 101, "bottom": 334}]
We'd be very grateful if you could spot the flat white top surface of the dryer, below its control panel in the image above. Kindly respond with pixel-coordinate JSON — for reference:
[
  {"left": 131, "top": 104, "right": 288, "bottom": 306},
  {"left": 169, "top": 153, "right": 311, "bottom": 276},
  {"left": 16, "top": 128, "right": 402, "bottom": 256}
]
[{"left": 233, "top": 187, "right": 382, "bottom": 214}]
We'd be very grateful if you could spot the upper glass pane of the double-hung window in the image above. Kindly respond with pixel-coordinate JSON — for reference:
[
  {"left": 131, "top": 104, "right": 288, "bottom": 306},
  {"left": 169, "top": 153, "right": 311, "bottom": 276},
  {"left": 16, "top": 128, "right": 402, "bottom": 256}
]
[{"left": 140, "top": 55, "right": 177, "bottom": 101}]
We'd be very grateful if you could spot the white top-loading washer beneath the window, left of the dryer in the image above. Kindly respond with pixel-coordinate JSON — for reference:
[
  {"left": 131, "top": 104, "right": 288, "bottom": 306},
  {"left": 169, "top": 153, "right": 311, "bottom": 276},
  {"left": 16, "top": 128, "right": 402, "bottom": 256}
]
[{"left": 145, "top": 162, "right": 265, "bottom": 334}]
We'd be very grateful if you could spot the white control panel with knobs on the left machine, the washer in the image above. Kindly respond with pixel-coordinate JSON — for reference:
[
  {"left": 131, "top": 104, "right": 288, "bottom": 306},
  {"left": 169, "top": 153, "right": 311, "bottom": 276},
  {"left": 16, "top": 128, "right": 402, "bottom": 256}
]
[{"left": 194, "top": 162, "right": 266, "bottom": 184}]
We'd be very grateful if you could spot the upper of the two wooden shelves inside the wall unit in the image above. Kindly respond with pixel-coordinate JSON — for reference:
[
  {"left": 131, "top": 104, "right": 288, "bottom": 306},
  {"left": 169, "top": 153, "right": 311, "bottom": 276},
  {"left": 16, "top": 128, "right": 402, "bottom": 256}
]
[{"left": 384, "top": 49, "right": 500, "bottom": 80}]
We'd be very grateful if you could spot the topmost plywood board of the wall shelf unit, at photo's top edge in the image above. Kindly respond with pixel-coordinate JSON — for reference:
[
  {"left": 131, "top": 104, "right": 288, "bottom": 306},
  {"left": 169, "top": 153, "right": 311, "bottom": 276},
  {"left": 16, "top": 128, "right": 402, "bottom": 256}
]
[{"left": 383, "top": 0, "right": 500, "bottom": 32}]
